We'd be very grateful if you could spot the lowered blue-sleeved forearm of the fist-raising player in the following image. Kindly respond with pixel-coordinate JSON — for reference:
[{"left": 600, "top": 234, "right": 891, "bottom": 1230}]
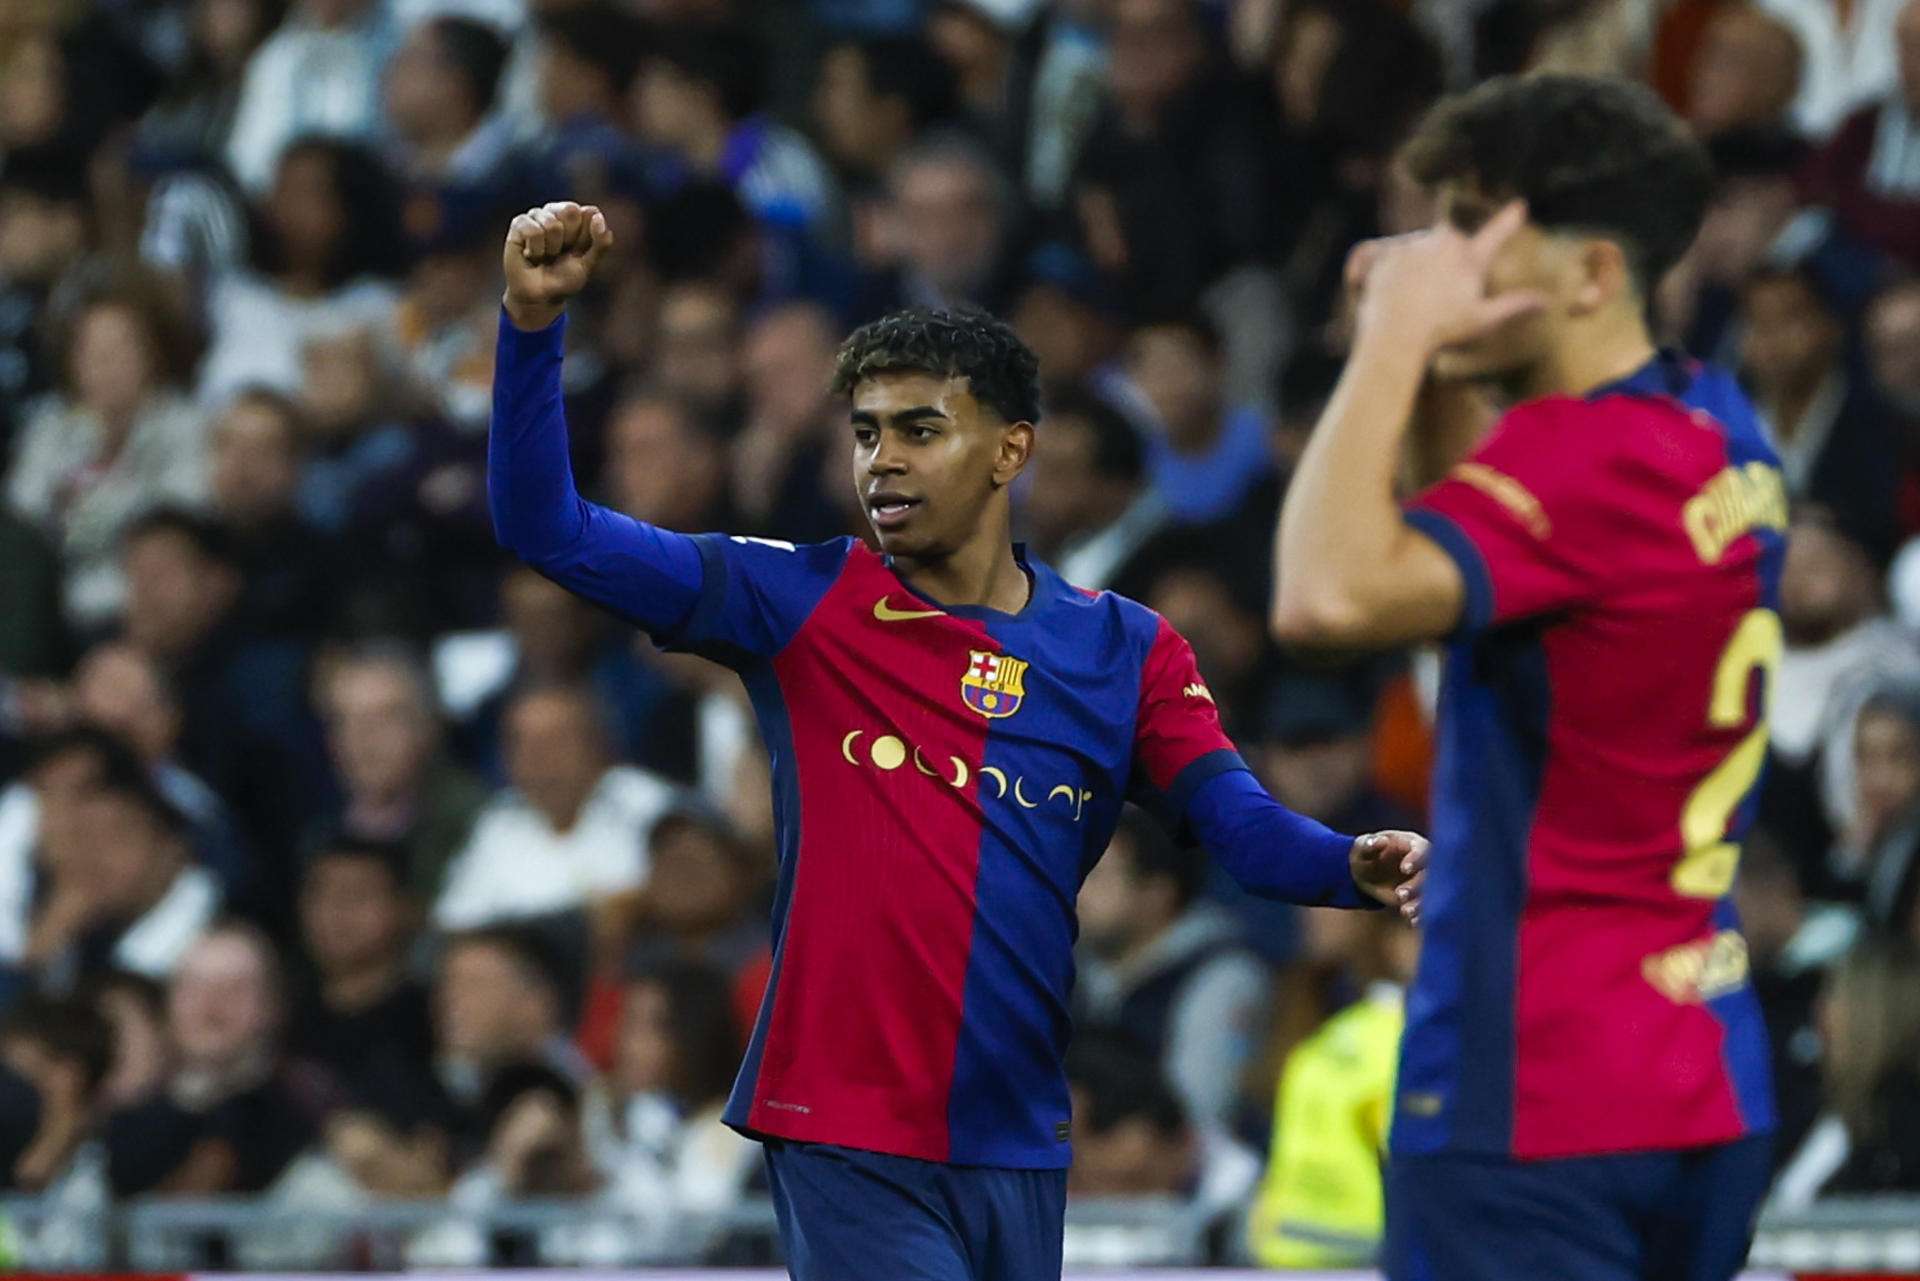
[{"left": 1187, "top": 770, "right": 1375, "bottom": 906}]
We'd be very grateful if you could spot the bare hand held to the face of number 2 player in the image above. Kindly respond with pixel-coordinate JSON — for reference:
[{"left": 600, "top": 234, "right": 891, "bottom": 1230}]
[{"left": 1346, "top": 200, "right": 1544, "bottom": 351}]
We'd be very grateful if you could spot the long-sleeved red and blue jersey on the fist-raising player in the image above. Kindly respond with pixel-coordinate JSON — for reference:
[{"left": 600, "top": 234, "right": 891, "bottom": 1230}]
[{"left": 488, "top": 319, "right": 1363, "bottom": 1168}]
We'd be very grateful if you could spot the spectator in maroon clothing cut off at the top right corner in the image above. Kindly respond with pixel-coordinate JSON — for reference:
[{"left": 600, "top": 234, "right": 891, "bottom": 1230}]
[{"left": 1807, "top": 0, "right": 1920, "bottom": 269}]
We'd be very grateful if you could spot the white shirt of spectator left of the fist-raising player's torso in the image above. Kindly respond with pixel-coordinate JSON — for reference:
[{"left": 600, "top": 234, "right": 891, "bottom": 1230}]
[{"left": 434, "top": 764, "right": 678, "bottom": 930}]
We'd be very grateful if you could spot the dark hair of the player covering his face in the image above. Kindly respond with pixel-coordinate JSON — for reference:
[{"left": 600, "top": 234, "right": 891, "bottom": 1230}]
[{"left": 1402, "top": 75, "right": 1713, "bottom": 296}]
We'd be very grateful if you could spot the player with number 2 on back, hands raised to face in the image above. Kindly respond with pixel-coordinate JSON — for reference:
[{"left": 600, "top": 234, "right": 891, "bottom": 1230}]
[{"left": 1273, "top": 75, "right": 1786, "bottom": 1281}]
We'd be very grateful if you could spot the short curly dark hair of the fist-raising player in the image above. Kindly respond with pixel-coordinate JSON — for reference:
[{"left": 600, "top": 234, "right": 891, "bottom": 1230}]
[{"left": 833, "top": 307, "right": 1041, "bottom": 423}]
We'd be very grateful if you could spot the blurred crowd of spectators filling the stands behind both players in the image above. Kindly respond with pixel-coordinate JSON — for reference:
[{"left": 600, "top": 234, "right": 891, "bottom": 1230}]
[{"left": 0, "top": 0, "right": 1920, "bottom": 1266}]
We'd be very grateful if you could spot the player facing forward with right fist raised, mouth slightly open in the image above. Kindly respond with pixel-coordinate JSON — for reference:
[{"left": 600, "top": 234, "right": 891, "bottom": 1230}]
[{"left": 490, "top": 204, "right": 1425, "bottom": 1281}]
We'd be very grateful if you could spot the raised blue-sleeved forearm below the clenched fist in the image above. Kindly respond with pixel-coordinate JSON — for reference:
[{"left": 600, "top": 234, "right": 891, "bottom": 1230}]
[{"left": 488, "top": 315, "right": 705, "bottom": 632}]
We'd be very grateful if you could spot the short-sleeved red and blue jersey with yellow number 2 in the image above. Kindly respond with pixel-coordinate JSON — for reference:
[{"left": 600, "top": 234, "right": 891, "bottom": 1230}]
[{"left": 1392, "top": 357, "right": 1786, "bottom": 1158}]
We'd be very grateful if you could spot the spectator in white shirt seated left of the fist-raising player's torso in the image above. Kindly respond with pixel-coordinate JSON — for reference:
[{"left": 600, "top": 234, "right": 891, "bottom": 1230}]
[{"left": 434, "top": 686, "right": 674, "bottom": 930}]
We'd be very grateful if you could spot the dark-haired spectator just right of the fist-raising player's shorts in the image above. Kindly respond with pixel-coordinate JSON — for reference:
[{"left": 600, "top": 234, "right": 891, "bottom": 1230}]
[{"left": 1066, "top": 1037, "right": 1260, "bottom": 1266}]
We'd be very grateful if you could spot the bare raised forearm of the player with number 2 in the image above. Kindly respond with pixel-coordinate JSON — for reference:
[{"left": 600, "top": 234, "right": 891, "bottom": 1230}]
[{"left": 1273, "top": 320, "right": 1428, "bottom": 643}]
